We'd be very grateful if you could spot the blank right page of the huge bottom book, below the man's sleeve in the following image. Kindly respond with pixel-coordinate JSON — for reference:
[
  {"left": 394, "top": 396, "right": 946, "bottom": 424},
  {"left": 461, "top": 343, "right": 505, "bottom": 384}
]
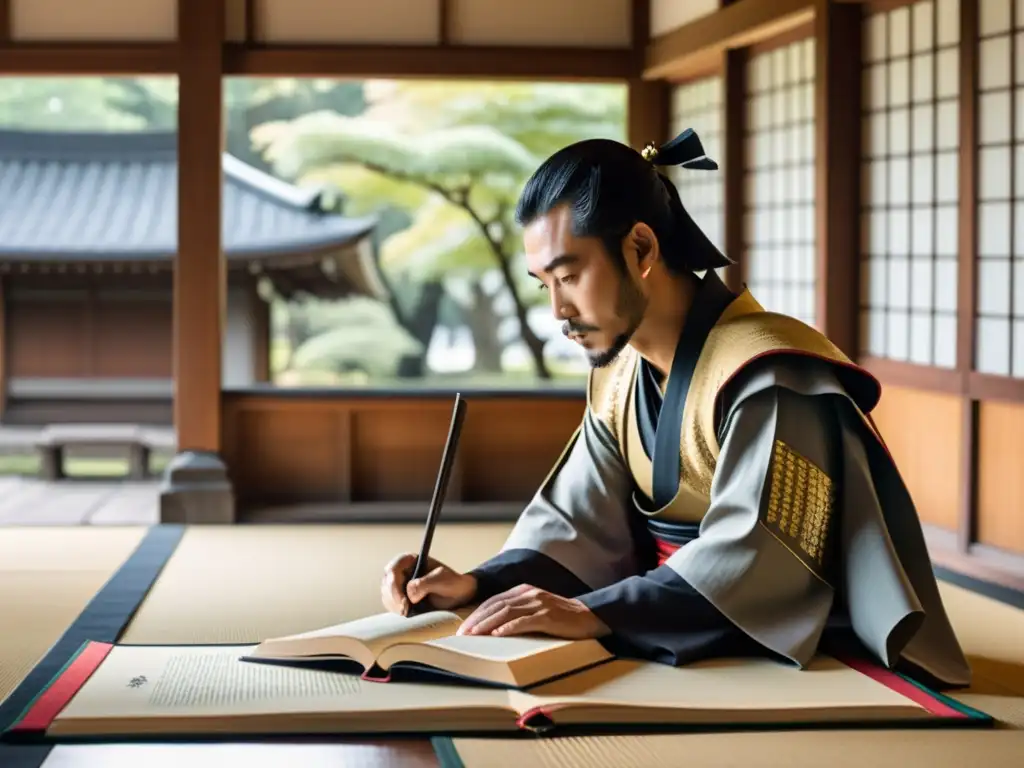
[{"left": 511, "top": 656, "right": 916, "bottom": 712}]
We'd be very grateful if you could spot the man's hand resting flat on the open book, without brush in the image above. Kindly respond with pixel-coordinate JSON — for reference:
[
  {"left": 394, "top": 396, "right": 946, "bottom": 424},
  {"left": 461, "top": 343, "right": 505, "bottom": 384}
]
[{"left": 458, "top": 584, "right": 610, "bottom": 640}]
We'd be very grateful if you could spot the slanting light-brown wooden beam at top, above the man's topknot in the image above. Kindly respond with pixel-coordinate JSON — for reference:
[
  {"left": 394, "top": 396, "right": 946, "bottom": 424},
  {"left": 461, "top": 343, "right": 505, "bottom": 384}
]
[{"left": 643, "top": 0, "right": 816, "bottom": 79}]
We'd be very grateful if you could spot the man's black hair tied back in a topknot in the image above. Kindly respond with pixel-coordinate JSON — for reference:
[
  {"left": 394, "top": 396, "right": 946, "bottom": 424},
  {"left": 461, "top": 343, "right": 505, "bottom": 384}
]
[{"left": 516, "top": 129, "right": 732, "bottom": 273}]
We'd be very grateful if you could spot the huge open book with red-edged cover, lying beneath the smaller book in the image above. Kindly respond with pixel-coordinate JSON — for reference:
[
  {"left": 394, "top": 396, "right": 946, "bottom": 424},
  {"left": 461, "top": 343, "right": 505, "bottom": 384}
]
[{"left": 5, "top": 643, "right": 992, "bottom": 740}]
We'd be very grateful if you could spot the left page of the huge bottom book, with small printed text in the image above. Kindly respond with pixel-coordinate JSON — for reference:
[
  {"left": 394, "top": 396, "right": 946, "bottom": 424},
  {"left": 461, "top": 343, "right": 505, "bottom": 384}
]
[{"left": 58, "top": 645, "right": 508, "bottom": 721}]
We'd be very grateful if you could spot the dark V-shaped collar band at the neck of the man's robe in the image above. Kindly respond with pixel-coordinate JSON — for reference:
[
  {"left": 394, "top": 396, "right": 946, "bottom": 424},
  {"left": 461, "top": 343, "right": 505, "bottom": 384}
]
[{"left": 636, "top": 270, "right": 736, "bottom": 509}]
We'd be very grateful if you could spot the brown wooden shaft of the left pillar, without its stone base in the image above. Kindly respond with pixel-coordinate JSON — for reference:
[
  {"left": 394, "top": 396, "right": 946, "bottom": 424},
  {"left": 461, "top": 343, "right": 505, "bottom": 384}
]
[{"left": 173, "top": 0, "right": 225, "bottom": 453}]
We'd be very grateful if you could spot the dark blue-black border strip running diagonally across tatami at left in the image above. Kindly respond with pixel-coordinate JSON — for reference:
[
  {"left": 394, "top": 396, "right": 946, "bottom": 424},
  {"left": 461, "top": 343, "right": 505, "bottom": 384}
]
[{"left": 0, "top": 525, "right": 184, "bottom": 768}]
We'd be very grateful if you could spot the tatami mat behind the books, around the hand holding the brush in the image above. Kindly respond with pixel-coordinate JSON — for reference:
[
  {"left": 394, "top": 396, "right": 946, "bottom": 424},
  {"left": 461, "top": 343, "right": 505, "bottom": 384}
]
[{"left": 123, "top": 523, "right": 510, "bottom": 643}]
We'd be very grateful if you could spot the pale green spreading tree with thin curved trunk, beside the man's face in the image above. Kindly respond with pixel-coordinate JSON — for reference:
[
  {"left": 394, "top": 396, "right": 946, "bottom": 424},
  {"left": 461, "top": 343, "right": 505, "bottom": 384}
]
[{"left": 253, "top": 112, "right": 550, "bottom": 379}]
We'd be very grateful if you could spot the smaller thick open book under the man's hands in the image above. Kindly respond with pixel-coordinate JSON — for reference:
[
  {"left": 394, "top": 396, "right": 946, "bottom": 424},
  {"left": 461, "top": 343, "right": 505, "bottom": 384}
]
[{"left": 237, "top": 610, "right": 613, "bottom": 688}]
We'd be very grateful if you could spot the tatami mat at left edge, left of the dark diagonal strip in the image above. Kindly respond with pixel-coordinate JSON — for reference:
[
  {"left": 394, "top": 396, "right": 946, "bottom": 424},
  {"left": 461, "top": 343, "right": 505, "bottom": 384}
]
[{"left": 0, "top": 527, "right": 145, "bottom": 701}]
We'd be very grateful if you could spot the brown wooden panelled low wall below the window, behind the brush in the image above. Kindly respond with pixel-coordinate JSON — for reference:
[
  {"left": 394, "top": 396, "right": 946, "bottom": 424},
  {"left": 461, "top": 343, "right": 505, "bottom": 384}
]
[{"left": 222, "top": 389, "right": 585, "bottom": 509}]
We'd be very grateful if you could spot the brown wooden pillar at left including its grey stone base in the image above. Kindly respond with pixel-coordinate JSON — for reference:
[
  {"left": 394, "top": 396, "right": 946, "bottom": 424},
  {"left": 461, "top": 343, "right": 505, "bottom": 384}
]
[{"left": 160, "top": 0, "right": 236, "bottom": 524}]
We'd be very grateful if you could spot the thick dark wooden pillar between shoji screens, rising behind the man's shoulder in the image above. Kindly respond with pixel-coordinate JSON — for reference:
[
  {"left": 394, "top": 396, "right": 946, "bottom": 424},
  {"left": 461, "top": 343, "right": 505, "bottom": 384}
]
[{"left": 814, "top": 0, "right": 862, "bottom": 358}]
